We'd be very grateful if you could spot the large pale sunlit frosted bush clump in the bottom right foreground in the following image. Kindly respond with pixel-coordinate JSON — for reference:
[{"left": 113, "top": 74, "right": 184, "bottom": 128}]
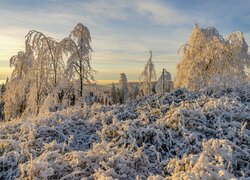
[{"left": 167, "top": 139, "right": 240, "bottom": 179}]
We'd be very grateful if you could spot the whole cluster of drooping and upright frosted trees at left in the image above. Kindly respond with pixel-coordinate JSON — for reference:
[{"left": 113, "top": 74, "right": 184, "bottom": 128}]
[{"left": 1, "top": 23, "right": 94, "bottom": 120}]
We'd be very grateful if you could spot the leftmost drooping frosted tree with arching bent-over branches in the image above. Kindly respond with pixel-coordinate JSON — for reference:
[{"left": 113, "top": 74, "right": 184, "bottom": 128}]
[{"left": 4, "top": 30, "right": 64, "bottom": 117}]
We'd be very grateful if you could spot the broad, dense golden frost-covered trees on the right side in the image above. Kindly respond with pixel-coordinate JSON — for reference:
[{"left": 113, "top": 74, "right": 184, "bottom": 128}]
[{"left": 174, "top": 25, "right": 250, "bottom": 90}]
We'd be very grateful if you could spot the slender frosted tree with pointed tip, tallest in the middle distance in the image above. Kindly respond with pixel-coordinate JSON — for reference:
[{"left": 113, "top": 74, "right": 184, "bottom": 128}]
[{"left": 140, "top": 50, "right": 156, "bottom": 95}]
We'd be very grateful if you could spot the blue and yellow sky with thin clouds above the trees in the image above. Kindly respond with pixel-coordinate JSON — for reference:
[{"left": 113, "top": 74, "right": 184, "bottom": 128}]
[{"left": 0, "top": 0, "right": 250, "bottom": 81}]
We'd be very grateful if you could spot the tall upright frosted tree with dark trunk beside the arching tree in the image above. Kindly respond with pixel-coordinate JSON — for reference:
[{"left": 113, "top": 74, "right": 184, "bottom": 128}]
[{"left": 59, "top": 23, "right": 94, "bottom": 97}]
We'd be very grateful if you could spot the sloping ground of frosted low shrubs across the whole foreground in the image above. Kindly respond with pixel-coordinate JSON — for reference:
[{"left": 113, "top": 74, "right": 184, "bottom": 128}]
[{"left": 0, "top": 87, "right": 250, "bottom": 179}]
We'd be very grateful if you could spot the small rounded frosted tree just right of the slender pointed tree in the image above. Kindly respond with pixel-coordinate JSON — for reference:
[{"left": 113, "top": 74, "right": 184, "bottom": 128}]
[{"left": 156, "top": 69, "right": 172, "bottom": 94}]
